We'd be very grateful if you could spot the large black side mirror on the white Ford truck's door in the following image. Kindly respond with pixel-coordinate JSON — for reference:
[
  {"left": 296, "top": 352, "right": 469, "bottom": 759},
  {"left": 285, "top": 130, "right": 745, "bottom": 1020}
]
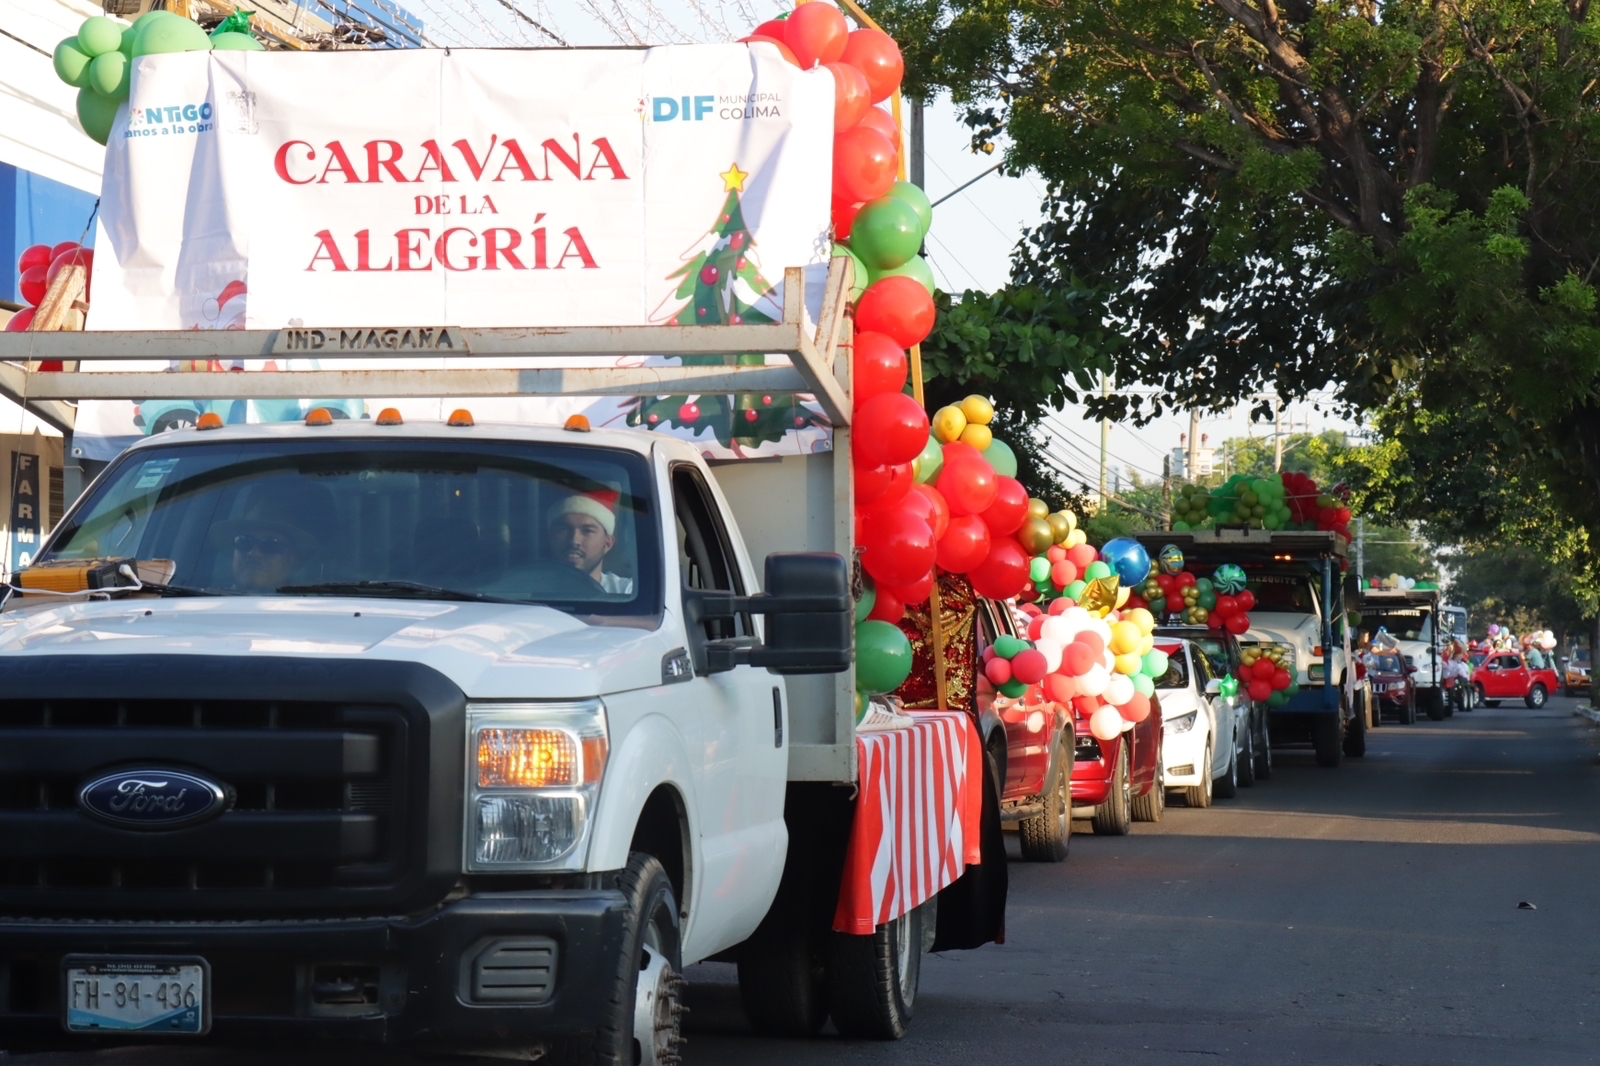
[{"left": 683, "top": 552, "right": 854, "bottom": 674}]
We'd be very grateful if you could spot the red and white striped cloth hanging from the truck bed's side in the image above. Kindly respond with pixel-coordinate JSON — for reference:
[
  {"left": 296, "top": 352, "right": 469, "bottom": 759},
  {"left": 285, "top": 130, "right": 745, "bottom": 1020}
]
[{"left": 834, "top": 711, "right": 982, "bottom": 935}]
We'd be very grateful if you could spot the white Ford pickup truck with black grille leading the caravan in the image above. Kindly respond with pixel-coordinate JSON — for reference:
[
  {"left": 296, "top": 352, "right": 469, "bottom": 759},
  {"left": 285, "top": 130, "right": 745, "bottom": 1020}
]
[{"left": 0, "top": 259, "right": 1003, "bottom": 1064}]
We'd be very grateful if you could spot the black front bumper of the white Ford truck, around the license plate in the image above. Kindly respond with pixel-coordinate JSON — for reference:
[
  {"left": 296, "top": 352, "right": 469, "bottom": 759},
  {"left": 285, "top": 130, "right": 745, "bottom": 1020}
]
[{"left": 0, "top": 890, "right": 626, "bottom": 1050}]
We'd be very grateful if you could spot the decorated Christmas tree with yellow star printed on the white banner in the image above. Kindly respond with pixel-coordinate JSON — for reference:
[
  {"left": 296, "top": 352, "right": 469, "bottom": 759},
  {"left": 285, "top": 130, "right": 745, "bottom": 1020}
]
[{"left": 627, "top": 163, "right": 827, "bottom": 451}]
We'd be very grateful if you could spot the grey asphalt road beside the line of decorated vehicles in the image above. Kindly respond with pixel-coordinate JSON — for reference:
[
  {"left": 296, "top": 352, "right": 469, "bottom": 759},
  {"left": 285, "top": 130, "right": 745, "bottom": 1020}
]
[{"left": 12, "top": 699, "right": 1600, "bottom": 1066}]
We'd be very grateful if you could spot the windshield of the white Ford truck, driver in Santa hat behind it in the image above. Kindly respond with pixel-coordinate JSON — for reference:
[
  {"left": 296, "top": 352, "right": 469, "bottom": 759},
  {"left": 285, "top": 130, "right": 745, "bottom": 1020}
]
[{"left": 38, "top": 439, "right": 661, "bottom": 616}]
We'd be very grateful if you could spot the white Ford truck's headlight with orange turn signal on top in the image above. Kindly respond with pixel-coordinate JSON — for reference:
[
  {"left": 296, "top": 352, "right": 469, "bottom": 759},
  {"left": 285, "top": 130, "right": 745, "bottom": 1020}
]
[{"left": 466, "top": 699, "right": 610, "bottom": 872}]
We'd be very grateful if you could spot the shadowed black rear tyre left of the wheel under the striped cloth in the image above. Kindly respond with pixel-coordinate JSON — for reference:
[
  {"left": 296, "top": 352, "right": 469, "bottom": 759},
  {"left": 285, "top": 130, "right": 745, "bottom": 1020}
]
[{"left": 739, "top": 908, "right": 827, "bottom": 1037}]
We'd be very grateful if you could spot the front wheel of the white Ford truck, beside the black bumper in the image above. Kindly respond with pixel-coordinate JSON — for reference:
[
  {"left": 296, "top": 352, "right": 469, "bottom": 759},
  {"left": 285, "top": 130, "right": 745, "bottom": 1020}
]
[{"left": 576, "top": 852, "right": 685, "bottom": 1066}]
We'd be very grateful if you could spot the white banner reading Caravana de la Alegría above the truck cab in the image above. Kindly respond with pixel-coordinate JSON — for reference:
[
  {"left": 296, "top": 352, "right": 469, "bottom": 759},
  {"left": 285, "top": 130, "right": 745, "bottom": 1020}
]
[{"left": 80, "top": 45, "right": 834, "bottom": 458}]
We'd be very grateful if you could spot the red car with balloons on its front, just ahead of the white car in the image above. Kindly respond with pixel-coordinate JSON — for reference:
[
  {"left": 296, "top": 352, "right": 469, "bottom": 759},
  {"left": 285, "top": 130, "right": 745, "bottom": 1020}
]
[{"left": 1072, "top": 675, "right": 1166, "bottom": 837}]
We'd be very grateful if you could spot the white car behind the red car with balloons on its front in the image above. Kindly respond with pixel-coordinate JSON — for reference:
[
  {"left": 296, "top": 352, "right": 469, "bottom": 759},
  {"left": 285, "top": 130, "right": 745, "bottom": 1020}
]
[{"left": 1155, "top": 640, "right": 1254, "bottom": 807}]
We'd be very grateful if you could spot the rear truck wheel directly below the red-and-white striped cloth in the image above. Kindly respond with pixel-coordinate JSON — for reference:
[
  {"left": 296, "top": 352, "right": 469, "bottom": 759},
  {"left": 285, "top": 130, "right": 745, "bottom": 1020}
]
[{"left": 829, "top": 908, "right": 922, "bottom": 1040}]
